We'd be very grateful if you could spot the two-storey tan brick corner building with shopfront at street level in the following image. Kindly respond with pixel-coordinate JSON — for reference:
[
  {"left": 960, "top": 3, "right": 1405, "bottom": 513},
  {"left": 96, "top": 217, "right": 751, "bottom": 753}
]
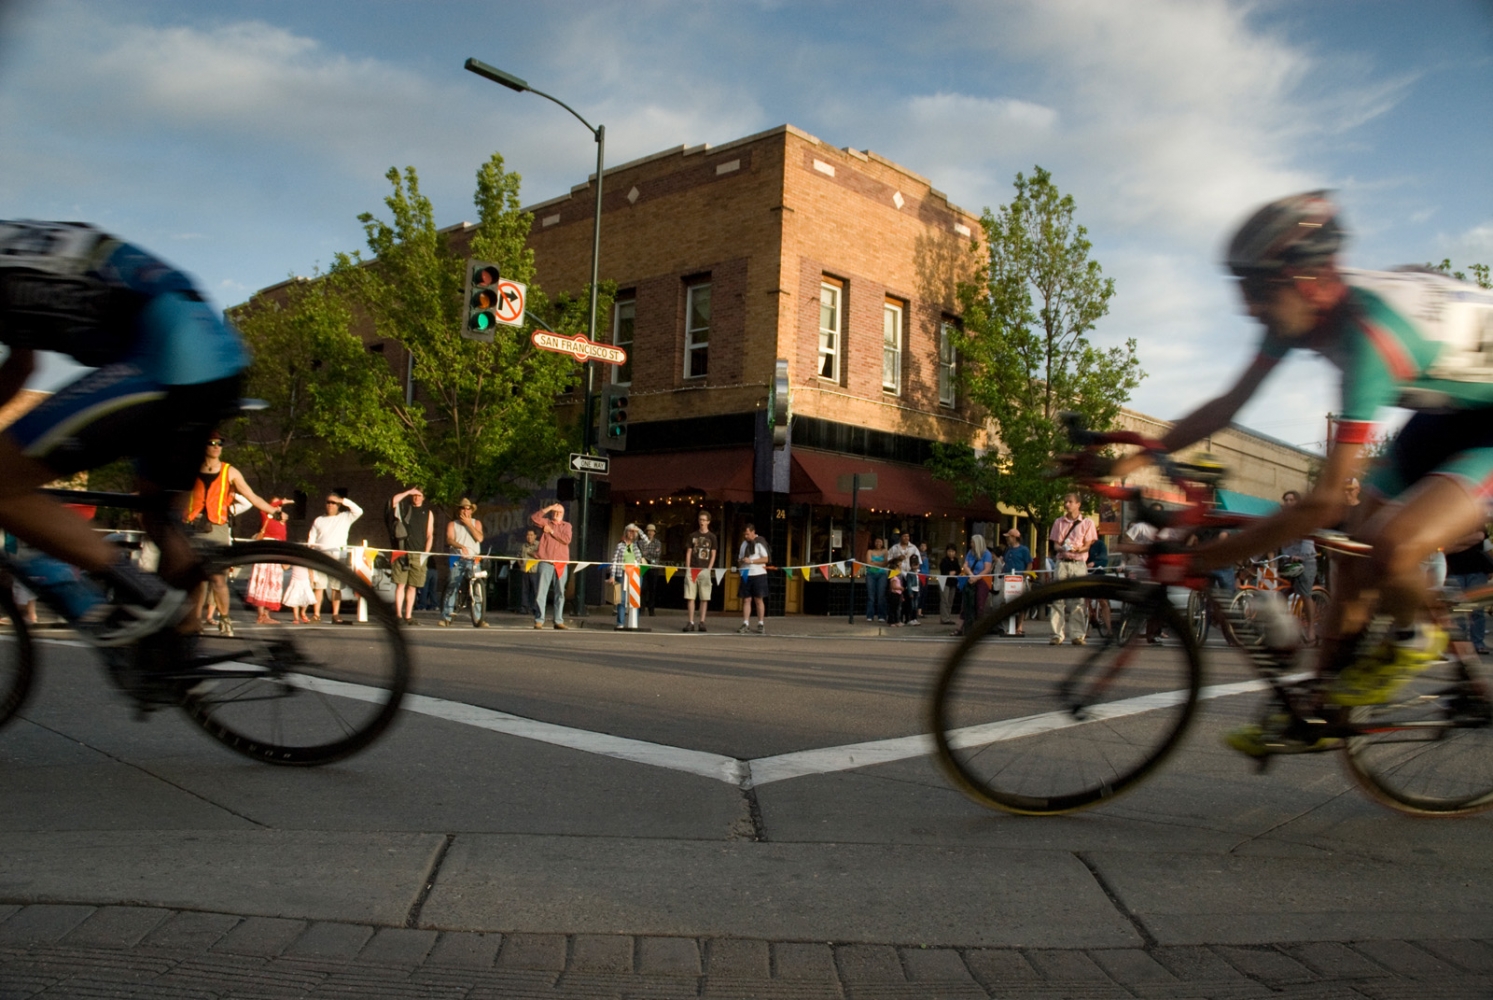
[{"left": 527, "top": 125, "right": 999, "bottom": 610}]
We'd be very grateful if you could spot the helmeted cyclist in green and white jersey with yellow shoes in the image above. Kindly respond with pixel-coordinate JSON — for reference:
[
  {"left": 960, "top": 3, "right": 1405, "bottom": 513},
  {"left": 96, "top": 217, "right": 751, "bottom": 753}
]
[{"left": 1112, "top": 191, "right": 1493, "bottom": 757}]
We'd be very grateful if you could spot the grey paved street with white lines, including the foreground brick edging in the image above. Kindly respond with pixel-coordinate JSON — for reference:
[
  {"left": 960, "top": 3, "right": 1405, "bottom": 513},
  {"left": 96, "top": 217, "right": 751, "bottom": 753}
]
[{"left": 0, "top": 605, "right": 1493, "bottom": 997}]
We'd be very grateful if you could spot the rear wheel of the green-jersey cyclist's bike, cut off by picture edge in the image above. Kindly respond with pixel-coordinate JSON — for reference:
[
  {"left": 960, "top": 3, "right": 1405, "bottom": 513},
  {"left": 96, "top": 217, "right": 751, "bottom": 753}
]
[{"left": 1344, "top": 660, "right": 1493, "bottom": 816}]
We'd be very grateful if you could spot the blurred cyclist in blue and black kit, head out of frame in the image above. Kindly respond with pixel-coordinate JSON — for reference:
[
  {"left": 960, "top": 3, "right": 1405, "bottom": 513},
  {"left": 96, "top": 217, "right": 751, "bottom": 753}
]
[{"left": 0, "top": 221, "right": 261, "bottom": 646}]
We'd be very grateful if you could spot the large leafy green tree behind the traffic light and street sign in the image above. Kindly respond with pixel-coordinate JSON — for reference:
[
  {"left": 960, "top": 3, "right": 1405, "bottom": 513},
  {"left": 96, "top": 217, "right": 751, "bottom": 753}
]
[{"left": 317, "top": 154, "right": 615, "bottom": 501}]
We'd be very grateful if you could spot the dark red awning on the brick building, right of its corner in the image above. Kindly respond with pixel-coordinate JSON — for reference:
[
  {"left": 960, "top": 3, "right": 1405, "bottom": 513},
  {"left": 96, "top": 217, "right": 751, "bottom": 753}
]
[{"left": 788, "top": 448, "right": 997, "bottom": 521}]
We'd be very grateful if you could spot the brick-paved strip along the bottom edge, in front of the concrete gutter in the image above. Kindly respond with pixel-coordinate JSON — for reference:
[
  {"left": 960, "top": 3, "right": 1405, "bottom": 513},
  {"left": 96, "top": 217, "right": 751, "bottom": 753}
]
[{"left": 0, "top": 904, "right": 1493, "bottom": 1000}]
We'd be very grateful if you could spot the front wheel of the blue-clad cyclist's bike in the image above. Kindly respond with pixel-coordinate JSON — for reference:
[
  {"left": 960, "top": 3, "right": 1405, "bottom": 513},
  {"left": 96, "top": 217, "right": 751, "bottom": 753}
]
[{"left": 182, "top": 542, "right": 411, "bottom": 766}]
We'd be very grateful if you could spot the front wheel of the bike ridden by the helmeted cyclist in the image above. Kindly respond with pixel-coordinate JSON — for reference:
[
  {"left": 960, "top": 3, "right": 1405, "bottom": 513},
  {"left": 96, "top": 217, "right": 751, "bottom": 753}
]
[{"left": 930, "top": 578, "right": 1202, "bottom": 815}]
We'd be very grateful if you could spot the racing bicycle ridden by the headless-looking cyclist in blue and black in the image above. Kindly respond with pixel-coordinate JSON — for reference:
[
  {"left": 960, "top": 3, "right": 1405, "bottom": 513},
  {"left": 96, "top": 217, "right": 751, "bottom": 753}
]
[{"left": 0, "top": 490, "right": 411, "bottom": 766}]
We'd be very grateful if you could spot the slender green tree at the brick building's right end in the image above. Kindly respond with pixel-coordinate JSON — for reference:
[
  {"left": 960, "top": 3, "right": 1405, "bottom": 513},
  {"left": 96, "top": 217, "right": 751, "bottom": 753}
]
[{"left": 929, "top": 167, "right": 1145, "bottom": 537}]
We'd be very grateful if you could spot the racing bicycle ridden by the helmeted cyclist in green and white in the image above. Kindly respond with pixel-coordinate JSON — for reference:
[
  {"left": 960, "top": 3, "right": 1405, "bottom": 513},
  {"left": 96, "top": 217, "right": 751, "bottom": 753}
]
[{"left": 930, "top": 417, "right": 1493, "bottom": 815}]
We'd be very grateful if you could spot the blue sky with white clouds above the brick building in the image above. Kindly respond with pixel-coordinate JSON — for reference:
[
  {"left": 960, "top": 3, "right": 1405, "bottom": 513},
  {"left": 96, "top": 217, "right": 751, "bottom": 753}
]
[{"left": 0, "top": 0, "right": 1493, "bottom": 445}]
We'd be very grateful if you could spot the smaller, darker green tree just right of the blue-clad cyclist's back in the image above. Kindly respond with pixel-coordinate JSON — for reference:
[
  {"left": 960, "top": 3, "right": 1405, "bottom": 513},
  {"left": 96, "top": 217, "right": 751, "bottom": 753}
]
[{"left": 224, "top": 276, "right": 376, "bottom": 497}]
